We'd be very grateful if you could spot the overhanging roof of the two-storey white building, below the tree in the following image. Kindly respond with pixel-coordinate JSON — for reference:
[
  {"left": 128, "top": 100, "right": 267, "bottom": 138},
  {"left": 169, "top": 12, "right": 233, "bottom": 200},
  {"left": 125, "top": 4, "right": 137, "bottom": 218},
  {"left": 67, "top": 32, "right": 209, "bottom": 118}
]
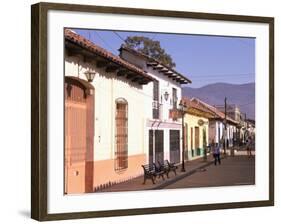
[{"left": 119, "top": 45, "right": 191, "bottom": 84}]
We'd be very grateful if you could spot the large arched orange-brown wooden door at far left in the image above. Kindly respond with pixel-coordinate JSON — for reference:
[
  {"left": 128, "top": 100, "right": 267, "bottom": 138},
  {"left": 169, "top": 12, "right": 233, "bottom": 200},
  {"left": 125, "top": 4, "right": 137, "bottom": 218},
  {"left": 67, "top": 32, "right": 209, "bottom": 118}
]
[{"left": 65, "top": 79, "right": 94, "bottom": 194}]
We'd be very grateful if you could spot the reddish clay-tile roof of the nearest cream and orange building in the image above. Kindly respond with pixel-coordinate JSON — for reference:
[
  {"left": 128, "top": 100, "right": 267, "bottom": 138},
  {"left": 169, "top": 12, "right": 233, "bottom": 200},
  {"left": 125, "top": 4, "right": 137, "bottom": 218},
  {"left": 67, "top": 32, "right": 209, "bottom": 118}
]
[{"left": 64, "top": 29, "right": 154, "bottom": 81}]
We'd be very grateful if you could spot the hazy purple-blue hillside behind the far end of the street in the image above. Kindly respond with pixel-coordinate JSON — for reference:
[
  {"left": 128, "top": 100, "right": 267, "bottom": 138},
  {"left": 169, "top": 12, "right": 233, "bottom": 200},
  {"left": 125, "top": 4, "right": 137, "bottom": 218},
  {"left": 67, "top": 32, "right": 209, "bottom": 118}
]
[{"left": 182, "top": 83, "right": 255, "bottom": 119}]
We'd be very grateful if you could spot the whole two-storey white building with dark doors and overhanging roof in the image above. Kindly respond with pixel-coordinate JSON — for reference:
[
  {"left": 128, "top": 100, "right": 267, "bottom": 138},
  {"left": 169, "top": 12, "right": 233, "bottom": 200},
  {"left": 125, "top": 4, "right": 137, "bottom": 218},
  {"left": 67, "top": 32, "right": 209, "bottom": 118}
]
[{"left": 120, "top": 47, "right": 191, "bottom": 164}]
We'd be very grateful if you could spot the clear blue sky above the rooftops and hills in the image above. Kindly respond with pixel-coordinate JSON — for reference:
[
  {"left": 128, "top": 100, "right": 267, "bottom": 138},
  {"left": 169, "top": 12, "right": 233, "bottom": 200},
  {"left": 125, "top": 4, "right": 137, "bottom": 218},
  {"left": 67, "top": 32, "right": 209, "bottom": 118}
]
[{"left": 74, "top": 29, "right": 255, "bottom": 88}]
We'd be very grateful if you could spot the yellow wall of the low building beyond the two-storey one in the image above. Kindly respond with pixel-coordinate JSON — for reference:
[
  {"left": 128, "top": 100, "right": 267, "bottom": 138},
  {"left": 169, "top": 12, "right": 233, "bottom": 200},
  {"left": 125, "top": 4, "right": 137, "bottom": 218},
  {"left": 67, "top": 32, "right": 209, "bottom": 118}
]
[{"left": 184, "top": 113, "right": 209, "bottom": 160}]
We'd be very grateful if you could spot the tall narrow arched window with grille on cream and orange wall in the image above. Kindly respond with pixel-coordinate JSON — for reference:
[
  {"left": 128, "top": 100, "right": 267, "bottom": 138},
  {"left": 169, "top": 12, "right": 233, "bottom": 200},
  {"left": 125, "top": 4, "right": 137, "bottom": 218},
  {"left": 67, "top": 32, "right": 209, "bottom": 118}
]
[{"left": 115, "top": 98, "right": 128, "bottom": 171}]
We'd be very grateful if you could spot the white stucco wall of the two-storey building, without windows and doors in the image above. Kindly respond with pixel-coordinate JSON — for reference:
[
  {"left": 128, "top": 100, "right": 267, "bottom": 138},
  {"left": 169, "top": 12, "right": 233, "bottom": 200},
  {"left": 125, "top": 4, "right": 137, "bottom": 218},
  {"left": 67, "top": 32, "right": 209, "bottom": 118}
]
[{"left": 121, "top": 50, "right": 182, "bottom": 163}]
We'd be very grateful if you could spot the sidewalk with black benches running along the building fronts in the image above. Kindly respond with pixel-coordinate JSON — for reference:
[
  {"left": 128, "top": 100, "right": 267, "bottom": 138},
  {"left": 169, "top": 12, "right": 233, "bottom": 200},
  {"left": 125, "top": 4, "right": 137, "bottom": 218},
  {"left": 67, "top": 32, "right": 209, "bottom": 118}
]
[{"left": 96, "top": 155, "right": 220, "bottom": 192}]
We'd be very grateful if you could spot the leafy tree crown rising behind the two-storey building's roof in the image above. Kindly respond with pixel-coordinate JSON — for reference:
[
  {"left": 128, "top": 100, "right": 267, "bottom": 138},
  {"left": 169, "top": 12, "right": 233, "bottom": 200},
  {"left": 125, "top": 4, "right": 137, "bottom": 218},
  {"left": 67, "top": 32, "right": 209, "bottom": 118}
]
[{"left": 125, "top": 36, "right": 176, "bottom": 68}]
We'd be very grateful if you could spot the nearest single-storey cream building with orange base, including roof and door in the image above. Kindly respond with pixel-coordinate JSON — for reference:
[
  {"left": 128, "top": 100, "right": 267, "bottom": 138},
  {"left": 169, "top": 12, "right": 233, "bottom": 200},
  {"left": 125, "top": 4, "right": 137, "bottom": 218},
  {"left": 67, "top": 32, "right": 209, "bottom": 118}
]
[{"left": 65, "top": 30, "right": 154, "bottom": 194}]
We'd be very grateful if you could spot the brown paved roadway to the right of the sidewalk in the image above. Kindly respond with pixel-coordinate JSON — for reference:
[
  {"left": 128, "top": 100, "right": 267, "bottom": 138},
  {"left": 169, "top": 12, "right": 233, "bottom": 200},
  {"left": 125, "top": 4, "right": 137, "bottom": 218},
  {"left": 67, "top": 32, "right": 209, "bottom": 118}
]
[{"left": 165, "top": 156, "right": 255, "bottom": 189}]
